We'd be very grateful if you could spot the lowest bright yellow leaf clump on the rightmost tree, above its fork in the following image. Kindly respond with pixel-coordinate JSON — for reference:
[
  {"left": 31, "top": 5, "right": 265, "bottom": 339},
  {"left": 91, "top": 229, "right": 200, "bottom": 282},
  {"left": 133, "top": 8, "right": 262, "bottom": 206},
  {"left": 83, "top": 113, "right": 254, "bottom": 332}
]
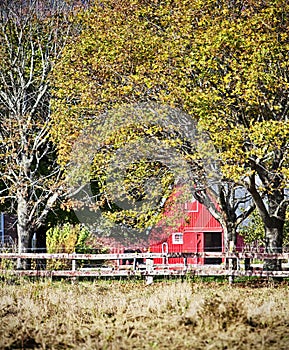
[{"left": 209, "top": 121, "right": 289, "bottom": 182}]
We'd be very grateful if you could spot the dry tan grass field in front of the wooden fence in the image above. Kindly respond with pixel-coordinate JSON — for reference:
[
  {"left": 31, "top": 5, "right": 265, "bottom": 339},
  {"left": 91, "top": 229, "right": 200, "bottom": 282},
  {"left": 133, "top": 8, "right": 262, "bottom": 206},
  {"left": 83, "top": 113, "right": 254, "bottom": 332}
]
[{"left": 0, "top": 280, "right": 289, "bottom": 350}]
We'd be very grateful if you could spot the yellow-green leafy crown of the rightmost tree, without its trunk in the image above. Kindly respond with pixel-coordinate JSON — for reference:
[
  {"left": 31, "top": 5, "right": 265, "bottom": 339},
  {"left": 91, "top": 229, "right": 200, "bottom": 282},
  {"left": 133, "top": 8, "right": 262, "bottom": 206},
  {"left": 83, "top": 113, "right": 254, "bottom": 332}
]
[{"left": 186, "top": 1, "right": 288, "bottom": 186}]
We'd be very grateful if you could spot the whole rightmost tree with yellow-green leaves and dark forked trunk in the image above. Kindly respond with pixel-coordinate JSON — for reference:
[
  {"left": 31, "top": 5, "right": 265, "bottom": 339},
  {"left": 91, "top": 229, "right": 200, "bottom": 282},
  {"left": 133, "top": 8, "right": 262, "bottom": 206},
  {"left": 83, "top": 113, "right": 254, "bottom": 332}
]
[{"left": 185, "top": 0, "right": 289, "bottom": 269}]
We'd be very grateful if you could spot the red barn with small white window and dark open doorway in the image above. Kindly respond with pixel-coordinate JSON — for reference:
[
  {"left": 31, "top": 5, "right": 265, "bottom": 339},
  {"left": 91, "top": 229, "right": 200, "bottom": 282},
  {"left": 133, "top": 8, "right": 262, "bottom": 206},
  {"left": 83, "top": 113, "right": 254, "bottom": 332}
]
[{"left": 150, "top": 200, "right": 224, "bottom": 264}]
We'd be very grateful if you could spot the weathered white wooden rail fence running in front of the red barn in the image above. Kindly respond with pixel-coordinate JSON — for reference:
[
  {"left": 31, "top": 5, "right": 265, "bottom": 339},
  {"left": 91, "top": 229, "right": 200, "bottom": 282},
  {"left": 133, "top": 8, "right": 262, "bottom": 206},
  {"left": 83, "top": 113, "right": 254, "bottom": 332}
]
[{"left": 0, "top": 252, "right": 289, "bottom": 283}]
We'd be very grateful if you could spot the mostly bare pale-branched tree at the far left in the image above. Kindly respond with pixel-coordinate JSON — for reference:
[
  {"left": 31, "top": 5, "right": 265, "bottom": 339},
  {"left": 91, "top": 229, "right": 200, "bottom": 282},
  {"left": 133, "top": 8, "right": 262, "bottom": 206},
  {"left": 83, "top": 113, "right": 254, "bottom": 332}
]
[{"left": 0, "top": 0, "right": 82, "bottom": 267}]
